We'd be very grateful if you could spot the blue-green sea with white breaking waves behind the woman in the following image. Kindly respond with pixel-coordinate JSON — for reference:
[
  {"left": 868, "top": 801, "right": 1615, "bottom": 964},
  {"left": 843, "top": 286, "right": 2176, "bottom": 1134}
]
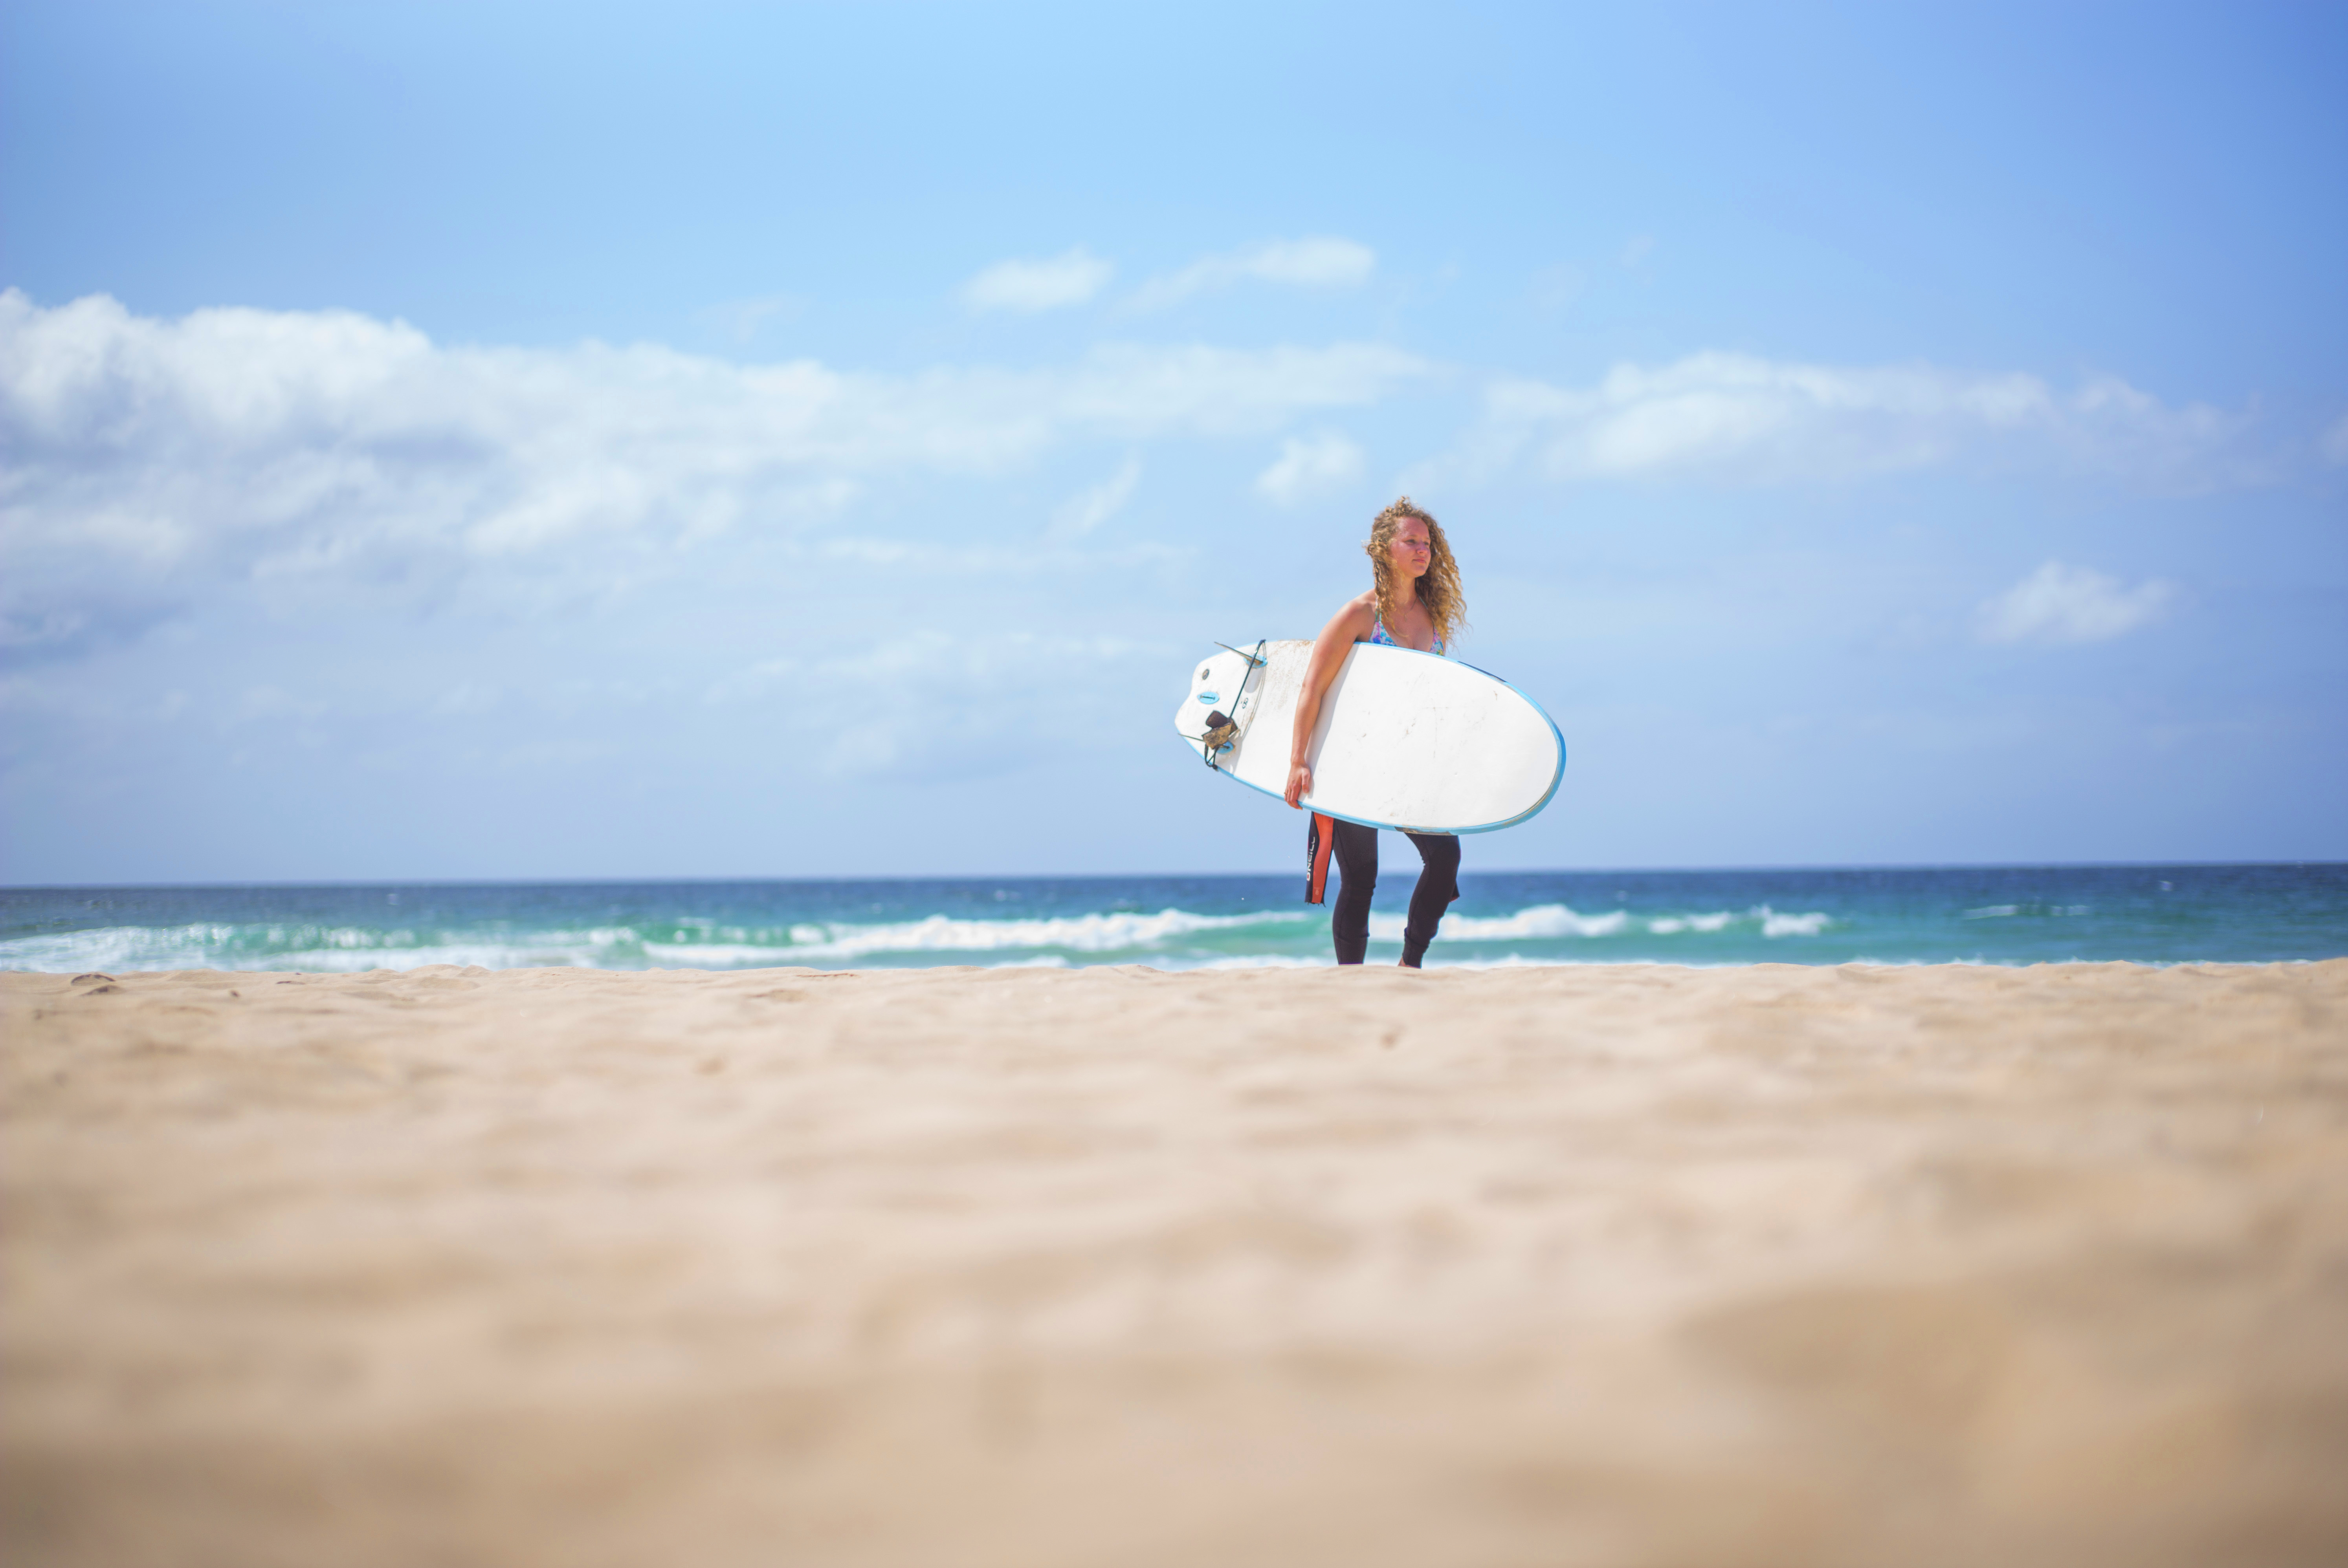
[{"left": 0, "top": 854, "right": 2348, "bottom": 972}]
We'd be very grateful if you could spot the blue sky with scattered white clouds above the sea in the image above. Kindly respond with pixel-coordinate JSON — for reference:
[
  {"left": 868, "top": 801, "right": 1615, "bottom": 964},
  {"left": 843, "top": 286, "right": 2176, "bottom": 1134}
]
[{"left": 0, "top": 2, "right": 2348, "bottom": 883}]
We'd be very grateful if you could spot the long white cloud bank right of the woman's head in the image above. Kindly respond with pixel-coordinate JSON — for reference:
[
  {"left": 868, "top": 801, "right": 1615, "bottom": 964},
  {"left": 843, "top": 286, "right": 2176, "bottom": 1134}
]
[{"left": 1456, "top": 352, "right": 2268, "bottom": 488}]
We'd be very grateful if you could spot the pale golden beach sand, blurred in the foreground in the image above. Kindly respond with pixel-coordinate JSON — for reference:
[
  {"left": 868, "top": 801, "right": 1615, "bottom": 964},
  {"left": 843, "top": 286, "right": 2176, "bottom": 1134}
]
[{"left": 0, "top": 960, "right": 2348, "bottom": 1568}]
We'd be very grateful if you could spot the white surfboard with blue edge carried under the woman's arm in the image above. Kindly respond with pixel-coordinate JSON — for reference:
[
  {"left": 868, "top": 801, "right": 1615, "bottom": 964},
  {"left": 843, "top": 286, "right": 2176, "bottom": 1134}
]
[{"left": 1174, "top": 641, "right": 1566, "bottom": 833}]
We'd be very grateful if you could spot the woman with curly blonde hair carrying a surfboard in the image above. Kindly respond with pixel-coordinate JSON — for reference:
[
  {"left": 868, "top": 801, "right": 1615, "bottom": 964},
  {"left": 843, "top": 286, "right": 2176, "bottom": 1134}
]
[{"left": 1287, "top": 495, "right": 1468, "bottom": 969}]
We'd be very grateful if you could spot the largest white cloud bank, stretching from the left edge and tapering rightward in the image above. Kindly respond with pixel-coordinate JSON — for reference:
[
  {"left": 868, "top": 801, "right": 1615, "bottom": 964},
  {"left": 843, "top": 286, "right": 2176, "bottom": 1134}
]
[{"left": 0, "top": 291, "right": 1427, "bottom": 645}]
